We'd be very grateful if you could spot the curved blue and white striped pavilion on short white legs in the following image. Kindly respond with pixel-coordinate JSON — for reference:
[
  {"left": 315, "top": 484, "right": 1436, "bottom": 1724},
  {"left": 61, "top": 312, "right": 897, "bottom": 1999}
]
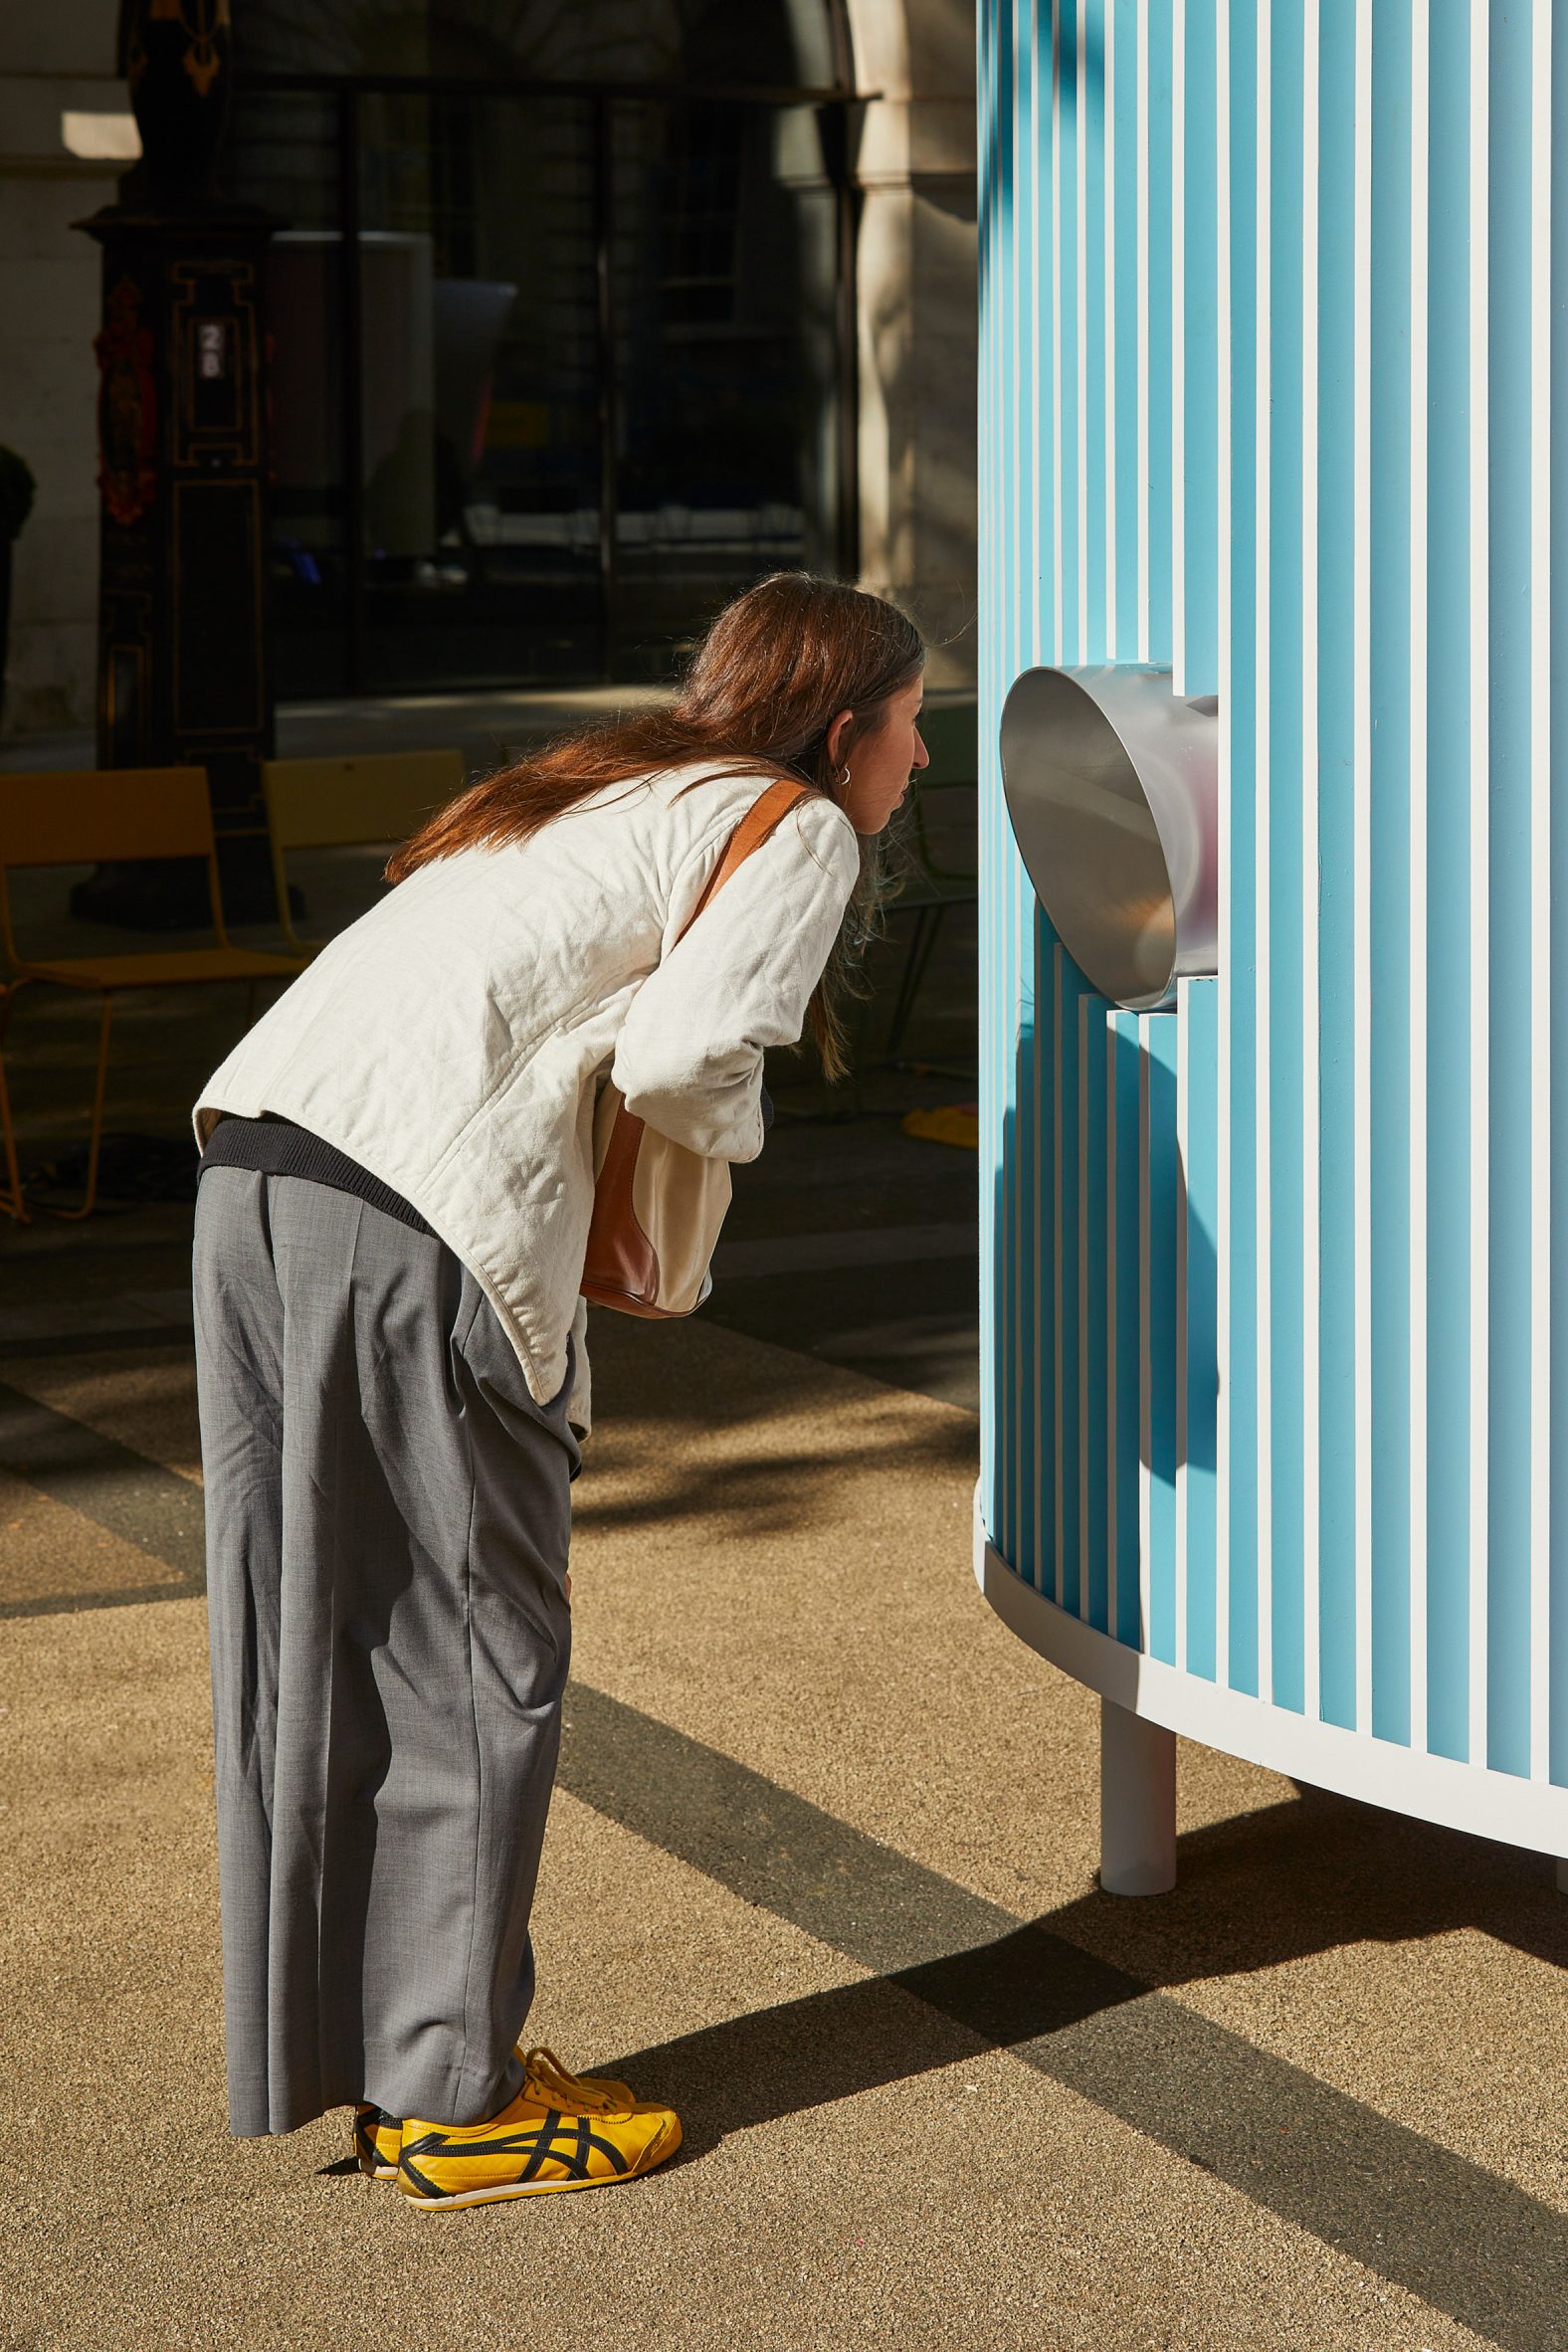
[{"left": 978, "top": 0, "right": 1568, "bottom": 1891}]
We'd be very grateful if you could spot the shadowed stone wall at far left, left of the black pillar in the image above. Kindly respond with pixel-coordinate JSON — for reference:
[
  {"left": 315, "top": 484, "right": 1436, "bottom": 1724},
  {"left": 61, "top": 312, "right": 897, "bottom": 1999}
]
[{"left": 0, "top": 0, "right": 124, "bottom": 734}]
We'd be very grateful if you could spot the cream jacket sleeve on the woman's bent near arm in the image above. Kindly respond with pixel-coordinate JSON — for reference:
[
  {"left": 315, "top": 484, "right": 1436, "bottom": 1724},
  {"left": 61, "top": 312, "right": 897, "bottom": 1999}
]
[{"left": 611, "top": 800, "right": 861, "bottom": 1159}]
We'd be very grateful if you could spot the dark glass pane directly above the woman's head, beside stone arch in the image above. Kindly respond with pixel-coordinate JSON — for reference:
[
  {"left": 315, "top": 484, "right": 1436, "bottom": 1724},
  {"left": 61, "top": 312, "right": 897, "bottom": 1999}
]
[{"left": 611, "top": 101, "right": 840, "bottom": 675}]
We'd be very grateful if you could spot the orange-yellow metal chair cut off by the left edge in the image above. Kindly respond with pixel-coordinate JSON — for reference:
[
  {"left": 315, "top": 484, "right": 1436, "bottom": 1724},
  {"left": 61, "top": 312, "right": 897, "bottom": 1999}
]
[{"left": 0, "top": 767, "right": 303, "bottom": 1223}]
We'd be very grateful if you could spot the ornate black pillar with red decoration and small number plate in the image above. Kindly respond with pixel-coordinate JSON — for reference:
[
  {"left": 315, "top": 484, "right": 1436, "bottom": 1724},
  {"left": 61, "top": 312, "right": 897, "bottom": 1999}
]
[{"left": 73, "top": 0, "right": 278, "bottom": 929}]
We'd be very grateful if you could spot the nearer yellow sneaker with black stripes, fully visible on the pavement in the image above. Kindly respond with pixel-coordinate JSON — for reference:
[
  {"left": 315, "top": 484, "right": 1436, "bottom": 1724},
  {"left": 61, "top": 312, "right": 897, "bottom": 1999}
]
[{"left": 397, "top": 2051, "right": 680, "bottom": 2214}]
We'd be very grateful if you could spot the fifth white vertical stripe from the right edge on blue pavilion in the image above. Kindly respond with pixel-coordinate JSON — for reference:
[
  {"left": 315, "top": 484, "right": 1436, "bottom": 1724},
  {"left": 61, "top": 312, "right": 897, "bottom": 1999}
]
[{"left": 1302, "top": 0, "right": 1321, "bottom": 1717}]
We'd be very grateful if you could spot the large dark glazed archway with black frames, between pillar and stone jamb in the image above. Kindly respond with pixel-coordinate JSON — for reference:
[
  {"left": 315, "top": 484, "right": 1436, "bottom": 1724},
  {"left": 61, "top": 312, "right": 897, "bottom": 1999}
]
[{"left": 233, "top": 0, "right": 856, "bottom": 696}]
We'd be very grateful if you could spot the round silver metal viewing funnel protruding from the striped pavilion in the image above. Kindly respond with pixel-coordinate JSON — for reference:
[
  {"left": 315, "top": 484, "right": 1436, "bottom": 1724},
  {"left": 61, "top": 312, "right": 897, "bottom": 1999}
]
[{"left": 1002, "top": 661, "right": 1220, "bottom": 1012}]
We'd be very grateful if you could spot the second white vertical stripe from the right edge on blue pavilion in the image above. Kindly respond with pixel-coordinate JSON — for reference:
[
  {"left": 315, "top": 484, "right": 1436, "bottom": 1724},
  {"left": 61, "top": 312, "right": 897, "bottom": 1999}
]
[{"left": 1470, "top": 5, "right": 1490, "bottom": 1764}]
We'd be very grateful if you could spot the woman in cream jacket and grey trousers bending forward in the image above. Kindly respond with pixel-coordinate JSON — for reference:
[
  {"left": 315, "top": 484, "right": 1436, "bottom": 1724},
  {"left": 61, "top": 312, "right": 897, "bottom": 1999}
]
[{"left": 195, "top": 574, "right": 926, "bottom": 2209}]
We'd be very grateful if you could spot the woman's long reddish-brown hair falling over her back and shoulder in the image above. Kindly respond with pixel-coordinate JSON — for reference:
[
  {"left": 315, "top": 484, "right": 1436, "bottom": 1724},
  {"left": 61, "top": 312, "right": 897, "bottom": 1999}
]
[{"left": 386, "top": 571, "right": 926, "bottom": 1078}]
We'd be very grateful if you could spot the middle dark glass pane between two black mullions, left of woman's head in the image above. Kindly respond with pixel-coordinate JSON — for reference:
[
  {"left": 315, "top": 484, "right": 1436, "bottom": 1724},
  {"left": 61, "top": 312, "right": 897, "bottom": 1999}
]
[{"left": 360, "top": 95, "right": 604, "bottom": 686}]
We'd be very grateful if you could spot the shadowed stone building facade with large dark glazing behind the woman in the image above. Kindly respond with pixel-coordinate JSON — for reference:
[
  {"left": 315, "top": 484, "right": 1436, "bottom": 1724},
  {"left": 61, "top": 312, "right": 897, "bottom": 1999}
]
[{"left": 0, "top": 0, "right": 976, "bottom": 731}]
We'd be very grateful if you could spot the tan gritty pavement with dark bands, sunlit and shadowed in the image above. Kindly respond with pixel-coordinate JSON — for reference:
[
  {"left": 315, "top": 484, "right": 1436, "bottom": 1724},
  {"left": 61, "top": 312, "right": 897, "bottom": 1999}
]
[{"left": 0, "top": 766, "right": 1568, "bottom": 2352}]
